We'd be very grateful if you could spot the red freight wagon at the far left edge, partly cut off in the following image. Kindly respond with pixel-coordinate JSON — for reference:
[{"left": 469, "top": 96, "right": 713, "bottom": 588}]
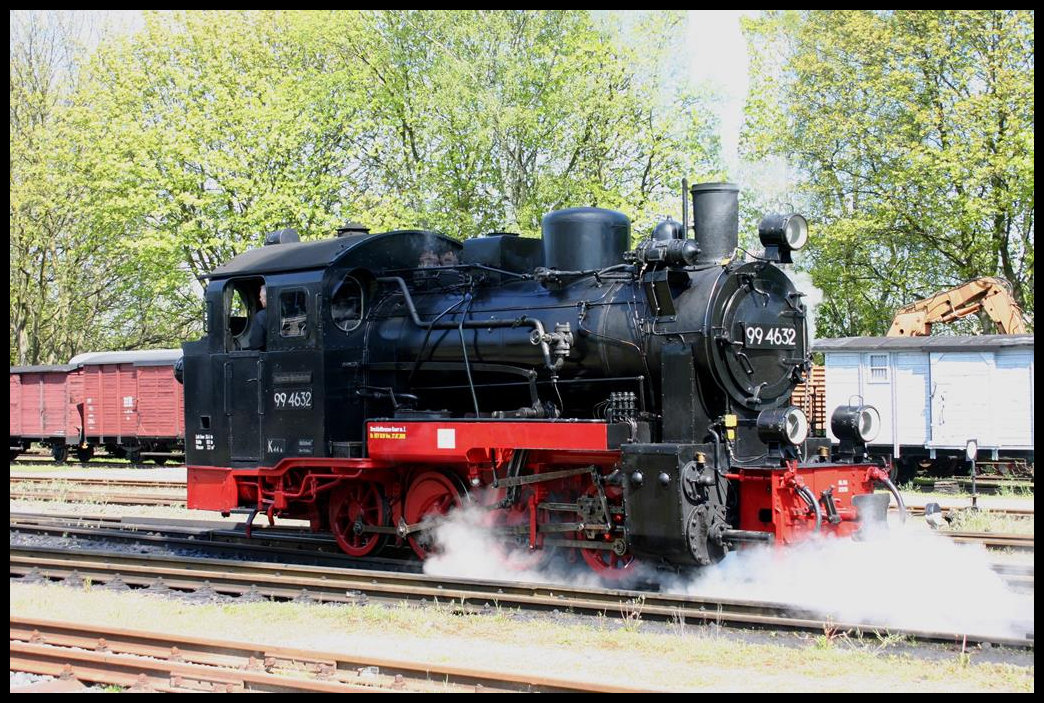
[{"left": 10, "top": 365, "right": 77, "bottom": 462}]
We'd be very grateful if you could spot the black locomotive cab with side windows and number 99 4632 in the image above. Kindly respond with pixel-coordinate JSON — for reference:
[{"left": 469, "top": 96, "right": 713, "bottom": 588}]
[{"left": 185, "top": 231, "right": 460, "bottom": 467}]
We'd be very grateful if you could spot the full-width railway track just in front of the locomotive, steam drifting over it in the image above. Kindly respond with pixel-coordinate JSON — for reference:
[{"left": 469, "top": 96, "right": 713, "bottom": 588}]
[{"left": 10, "top": 545, "right": 1033, "bottom": 648}]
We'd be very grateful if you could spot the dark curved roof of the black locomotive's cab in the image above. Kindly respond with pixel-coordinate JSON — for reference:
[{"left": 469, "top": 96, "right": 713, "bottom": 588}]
[{"left": 207, "top": 230, "right": 461, "bottom": 278}]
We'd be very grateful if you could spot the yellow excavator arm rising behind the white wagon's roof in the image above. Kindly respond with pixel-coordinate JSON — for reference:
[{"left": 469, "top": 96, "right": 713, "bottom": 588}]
[{"left": 887, "top": 277, "right": 1026, "bottom": 336}]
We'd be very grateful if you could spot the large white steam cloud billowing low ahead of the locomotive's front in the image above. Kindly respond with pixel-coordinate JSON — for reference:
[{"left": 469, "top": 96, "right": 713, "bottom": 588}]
[{"left": 668, "top": 529, "right": 1034, "bottom": 637}]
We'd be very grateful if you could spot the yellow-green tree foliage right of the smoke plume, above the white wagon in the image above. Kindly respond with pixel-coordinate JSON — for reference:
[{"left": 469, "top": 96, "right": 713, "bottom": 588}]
[{"left": 744, "top": 10, "right": 1034, "bottom": 335}]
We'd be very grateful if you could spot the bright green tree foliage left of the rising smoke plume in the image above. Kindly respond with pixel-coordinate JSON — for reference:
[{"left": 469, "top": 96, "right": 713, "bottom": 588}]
[{"left": 11, "top": 10, "right": 718, "bottom": 364}]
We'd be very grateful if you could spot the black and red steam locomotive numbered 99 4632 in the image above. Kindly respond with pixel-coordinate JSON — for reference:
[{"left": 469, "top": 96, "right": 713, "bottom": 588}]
[{"left": 184, "top": 184, "right": 898, "bottom": 576}]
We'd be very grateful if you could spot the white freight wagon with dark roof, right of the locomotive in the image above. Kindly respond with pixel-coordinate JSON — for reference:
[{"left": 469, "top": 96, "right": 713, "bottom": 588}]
[{"left": 812, "top": 334, "right": 1034, "bottom": 475}]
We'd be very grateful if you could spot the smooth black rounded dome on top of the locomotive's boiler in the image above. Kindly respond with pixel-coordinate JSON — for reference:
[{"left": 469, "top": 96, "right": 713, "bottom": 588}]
[{"left": 541, "top": 208, "right": 631, "bottom": 271}]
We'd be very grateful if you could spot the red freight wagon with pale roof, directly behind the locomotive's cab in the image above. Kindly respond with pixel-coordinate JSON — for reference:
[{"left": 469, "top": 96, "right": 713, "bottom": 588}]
[{"left": 69, "top": 349, "right": 185, "bottom": 464}]
